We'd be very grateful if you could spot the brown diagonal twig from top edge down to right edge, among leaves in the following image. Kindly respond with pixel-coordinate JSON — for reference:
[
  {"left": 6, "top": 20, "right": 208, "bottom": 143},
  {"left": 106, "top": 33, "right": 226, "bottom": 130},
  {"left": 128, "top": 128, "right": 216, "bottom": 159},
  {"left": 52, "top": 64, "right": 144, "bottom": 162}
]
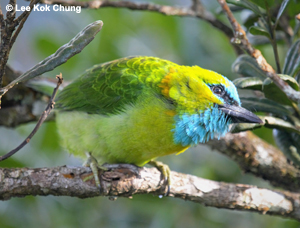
[{"left": 218, "top": 0, "right": 300, "bottom": 103}]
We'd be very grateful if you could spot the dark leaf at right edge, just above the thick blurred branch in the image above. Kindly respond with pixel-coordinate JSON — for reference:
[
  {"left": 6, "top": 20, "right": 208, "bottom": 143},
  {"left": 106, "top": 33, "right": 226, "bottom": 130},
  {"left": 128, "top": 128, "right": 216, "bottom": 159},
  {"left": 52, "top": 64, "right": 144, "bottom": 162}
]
[{"left": 273, "top": 129, "right": 300, "bottom": 166}]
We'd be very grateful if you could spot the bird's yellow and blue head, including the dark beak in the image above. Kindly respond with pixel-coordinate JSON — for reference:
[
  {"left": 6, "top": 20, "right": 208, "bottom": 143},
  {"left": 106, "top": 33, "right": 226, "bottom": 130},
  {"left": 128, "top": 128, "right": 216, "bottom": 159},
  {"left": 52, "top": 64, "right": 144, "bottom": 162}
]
[{"left": 161, "top": 66, "right": 262, "bottom": 146}]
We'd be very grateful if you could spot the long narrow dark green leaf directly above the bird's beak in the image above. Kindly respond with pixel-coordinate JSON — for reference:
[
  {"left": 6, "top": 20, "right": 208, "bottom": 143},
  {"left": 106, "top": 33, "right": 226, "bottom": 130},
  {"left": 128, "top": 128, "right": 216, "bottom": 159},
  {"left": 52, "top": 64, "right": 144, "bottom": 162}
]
[{"left": 240, "top": 97, "right": 292, "bottom": 117}]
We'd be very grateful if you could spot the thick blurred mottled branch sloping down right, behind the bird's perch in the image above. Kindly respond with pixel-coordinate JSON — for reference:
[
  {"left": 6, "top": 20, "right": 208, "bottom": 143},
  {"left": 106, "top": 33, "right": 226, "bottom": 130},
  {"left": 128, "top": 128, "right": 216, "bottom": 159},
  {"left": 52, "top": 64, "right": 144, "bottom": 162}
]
[{"left": 207, "top": 131, "right": 300, "bottom": 192}]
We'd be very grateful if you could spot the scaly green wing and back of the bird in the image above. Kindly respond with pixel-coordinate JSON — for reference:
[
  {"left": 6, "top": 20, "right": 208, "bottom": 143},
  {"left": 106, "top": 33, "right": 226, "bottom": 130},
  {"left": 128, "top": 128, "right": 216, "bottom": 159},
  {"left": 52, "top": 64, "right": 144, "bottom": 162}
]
[{"left": 56, "top": 57, "right": 176, "bottom": 115}]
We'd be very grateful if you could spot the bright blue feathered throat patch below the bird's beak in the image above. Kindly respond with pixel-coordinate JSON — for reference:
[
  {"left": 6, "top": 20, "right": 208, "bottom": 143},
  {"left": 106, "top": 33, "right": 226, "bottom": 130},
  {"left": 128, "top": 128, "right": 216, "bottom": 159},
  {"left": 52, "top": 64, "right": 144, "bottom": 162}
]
[{"left": 172, "top": 105, "right": 231, "bottom": 146}]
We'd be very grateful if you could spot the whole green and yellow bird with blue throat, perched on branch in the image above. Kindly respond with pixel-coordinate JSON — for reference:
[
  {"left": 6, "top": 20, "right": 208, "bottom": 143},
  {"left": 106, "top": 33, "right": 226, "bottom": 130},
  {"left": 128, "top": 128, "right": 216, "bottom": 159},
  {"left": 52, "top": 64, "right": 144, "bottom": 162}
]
[{"left": 55, "top": 56, "right": 262, "bottom": 191}]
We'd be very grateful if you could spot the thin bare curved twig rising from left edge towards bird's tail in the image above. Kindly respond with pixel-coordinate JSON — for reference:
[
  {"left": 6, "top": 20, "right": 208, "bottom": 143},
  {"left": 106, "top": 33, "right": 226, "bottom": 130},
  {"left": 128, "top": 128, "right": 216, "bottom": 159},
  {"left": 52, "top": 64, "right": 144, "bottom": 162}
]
[{"left": 0, "top": 74, "right": 63, "bottom": 161}]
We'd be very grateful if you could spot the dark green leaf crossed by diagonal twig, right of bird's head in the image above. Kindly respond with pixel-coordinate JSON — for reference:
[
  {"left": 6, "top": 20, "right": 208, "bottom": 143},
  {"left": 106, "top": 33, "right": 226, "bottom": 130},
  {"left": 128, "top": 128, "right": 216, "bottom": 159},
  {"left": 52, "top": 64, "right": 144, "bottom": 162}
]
[{"left": 263, "top": 74, "right": 299, "bottom": 106}]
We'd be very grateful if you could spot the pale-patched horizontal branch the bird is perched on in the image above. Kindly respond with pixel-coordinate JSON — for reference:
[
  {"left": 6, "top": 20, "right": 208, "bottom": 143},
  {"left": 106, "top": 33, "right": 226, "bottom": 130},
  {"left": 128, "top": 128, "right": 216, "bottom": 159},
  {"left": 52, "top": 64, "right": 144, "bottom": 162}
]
[{"left": 0, "top": 164, "right": 300, "bottom": 220}]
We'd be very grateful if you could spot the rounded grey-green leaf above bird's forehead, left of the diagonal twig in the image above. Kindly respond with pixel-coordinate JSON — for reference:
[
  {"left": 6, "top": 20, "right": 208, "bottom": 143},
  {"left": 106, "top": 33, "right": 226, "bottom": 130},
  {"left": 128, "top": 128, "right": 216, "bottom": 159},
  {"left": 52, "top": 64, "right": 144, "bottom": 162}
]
[{"left": 231, "top": 55, "right": 266, "bottom": 80}]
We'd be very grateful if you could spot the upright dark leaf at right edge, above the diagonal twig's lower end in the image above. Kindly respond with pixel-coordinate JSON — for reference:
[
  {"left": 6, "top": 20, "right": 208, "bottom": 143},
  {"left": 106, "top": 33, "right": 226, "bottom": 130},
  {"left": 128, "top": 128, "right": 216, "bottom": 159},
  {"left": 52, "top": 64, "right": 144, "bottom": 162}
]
[{"left": 282, "top": 39, "right": 300, "bottom": 77}]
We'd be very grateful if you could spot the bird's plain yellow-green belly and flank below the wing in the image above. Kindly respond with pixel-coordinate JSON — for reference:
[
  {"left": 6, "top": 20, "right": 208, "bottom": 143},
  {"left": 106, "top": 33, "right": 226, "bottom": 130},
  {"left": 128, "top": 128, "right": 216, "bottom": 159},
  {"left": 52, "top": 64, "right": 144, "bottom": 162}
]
[{"left": 57, "top": 94, "right": 187, "bottom": 166}]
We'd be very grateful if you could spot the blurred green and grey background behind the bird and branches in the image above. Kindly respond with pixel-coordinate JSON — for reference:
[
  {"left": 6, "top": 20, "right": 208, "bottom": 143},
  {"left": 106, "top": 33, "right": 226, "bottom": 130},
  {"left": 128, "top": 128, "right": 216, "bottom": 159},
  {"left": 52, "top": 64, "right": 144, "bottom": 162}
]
[{"left": 0, "top": 0, "right": 299, "bottom": 228}]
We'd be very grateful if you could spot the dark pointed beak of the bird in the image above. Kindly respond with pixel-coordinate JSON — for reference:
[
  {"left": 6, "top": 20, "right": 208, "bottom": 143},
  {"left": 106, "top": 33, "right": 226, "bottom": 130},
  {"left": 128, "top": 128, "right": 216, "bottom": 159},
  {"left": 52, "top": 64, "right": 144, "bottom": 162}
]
[{"left": 219, "top": 104, "right": 263, "bottom": 123}]
